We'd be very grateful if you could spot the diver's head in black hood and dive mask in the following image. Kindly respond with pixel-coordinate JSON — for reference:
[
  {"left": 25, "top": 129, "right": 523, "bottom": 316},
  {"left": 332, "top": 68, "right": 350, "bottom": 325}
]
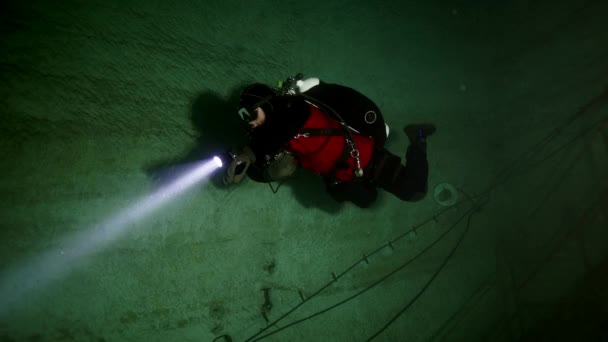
[{"left": 239, "top": 83, "right": 275, "bottom": 128}]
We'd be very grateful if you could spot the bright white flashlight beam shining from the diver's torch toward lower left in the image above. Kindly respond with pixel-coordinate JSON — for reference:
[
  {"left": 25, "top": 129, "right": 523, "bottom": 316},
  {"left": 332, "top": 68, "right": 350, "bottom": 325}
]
[{"left": 0, "top": 157, "right": 221, "bottom": 318}]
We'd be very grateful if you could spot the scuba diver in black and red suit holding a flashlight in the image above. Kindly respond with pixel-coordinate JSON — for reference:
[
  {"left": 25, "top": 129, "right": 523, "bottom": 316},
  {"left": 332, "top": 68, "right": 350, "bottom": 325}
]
[{"left": 223, "top": 74, "right": 435, "bottom": 208}]
